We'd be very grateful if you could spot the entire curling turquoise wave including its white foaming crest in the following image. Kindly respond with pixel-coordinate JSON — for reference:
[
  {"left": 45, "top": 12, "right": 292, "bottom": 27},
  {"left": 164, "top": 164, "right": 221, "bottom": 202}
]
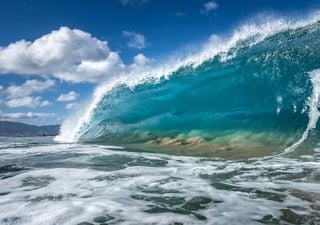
[{"left": 56, "top": 12, "right": 320, "bottom": 157}]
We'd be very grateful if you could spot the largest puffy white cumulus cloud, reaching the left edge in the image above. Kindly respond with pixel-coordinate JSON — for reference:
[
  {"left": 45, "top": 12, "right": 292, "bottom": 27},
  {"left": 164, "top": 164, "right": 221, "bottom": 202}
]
[{"left": 0, "top": 27, "right": 124, "bottom": 83}]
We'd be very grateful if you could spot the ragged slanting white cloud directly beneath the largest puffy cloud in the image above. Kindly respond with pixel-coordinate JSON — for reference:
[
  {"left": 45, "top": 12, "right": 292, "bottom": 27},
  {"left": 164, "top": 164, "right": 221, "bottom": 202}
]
[{"left": 5, "top": 80, "right": 55, "bottom": 98}]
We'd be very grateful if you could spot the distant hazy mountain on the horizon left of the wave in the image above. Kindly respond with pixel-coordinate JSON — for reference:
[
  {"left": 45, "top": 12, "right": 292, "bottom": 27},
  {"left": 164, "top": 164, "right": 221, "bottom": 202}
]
[{"left": 0, "top": 121, "right": 60, "bottom": 137}]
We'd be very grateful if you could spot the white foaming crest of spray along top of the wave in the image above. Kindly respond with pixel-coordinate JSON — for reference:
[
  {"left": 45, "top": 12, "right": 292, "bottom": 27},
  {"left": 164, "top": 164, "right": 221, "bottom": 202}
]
[{"left": 55, "top": 12, "right": 320, "bottom": 142}]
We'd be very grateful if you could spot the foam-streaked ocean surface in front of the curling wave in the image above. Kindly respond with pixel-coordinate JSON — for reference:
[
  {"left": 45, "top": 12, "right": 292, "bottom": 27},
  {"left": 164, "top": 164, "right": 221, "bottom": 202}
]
[{"left": 0, "top": 137, "right": 320, "bottom": 225}]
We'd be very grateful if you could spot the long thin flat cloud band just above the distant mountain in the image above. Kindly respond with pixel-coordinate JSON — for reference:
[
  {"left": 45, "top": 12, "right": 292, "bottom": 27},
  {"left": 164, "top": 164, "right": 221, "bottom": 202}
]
[{"left": 0, "top": 111, "right": 56, "bottom": 120}]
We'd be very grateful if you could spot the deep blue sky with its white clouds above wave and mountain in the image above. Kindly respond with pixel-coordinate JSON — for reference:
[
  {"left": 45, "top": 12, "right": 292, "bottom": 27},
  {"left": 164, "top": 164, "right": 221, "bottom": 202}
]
[{"left": 0, "top": 0, "right": 320, "bottom": 124}]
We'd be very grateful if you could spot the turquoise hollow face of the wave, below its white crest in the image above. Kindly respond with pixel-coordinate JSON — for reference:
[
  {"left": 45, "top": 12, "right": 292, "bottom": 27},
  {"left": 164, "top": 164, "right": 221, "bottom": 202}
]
[{"left": 77, "top": 22, "right": 320, "bottom": 158}]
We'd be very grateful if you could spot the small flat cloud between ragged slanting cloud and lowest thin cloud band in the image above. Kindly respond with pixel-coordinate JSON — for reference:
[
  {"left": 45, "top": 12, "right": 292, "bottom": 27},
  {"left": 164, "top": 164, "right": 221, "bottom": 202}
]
[{"left": 5, "top": 96, "right": 51, "bottom": 108}]
